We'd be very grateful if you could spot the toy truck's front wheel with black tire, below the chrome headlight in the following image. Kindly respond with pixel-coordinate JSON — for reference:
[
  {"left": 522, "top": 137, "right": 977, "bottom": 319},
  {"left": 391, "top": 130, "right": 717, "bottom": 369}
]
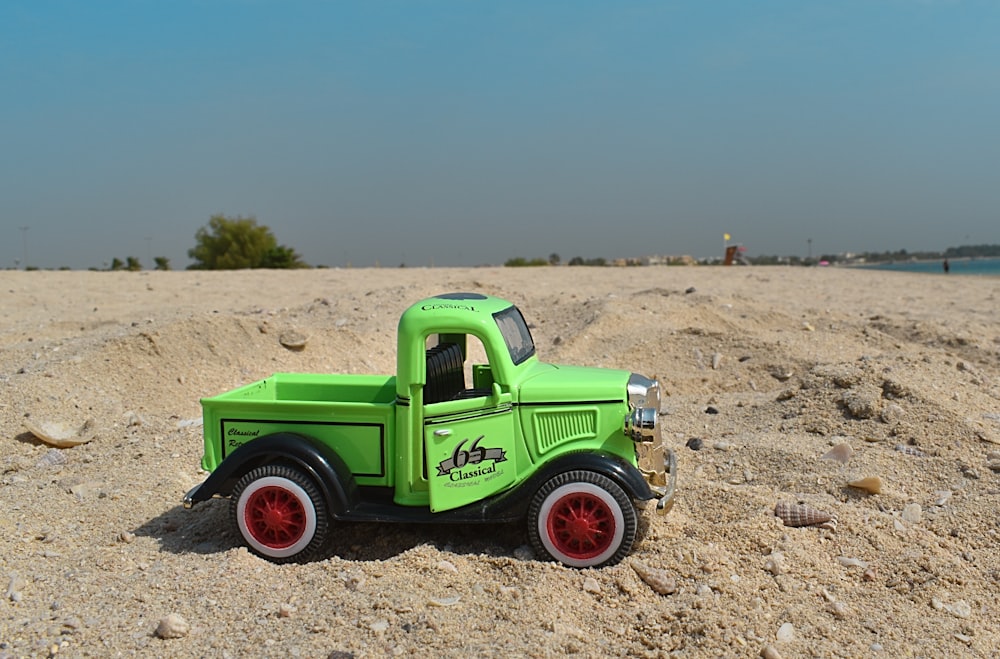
[{"left": 528, "top": 470, "right": 638, "bottom": 568}]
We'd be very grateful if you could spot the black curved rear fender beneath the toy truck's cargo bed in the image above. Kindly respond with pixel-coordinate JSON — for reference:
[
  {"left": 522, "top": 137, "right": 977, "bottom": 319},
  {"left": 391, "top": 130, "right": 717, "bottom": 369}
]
[{"left": 184, "top": 432, "right": 361, "bottom": 517}]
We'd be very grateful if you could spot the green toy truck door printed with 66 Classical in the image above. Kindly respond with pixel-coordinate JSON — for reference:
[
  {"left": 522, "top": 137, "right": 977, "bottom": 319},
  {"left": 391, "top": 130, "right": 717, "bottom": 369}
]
[{"left": 424, "top": 388, "right": 515, "bottom": 512}]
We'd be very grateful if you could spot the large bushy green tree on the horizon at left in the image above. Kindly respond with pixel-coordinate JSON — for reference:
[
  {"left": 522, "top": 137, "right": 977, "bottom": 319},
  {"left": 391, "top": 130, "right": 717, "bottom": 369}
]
[{"left": 188, "top": 215, "right": 309, "bottom": 270}]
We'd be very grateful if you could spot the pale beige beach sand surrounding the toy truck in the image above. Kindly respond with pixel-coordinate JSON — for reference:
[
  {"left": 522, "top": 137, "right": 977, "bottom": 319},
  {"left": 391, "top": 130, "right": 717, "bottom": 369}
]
[{"left": 0, "top": 267, "right": 1000, "bottom": 657}]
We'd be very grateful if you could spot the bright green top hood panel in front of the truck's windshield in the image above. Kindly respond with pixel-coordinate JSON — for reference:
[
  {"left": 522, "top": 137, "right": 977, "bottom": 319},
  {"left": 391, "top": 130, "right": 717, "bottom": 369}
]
[{"left": 518, "top": 363, "right": 630, "bottom": 404}]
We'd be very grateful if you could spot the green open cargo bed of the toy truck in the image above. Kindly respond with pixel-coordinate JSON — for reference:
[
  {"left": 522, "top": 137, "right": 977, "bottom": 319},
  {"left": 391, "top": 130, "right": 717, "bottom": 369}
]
[{"left": 201, "top": 373, "right": 396, "bottom": 485}]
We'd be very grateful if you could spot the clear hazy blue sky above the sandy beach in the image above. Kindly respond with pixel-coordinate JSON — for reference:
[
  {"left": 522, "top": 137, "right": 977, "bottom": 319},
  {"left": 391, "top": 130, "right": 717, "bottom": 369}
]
[{"left": 0, "top": 0, "right": 1000, "bottom": 268}]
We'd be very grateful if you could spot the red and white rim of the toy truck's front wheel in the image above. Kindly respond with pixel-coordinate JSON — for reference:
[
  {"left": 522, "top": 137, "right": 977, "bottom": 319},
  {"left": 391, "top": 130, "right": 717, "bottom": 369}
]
[{"left": 545, "top": 492, "right": 615, "bottom": 560}]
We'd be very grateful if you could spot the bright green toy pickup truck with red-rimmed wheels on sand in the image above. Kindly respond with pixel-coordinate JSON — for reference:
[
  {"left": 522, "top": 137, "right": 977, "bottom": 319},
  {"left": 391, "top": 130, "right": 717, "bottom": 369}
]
[{"left": 184, "top": 293, "right": 676, "bottom": 568}]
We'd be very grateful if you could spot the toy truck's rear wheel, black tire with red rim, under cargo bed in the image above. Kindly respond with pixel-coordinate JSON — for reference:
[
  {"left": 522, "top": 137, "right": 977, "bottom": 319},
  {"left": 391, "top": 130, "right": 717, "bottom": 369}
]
[{"left": 230, "top": 464, "right": 330, "bottom": 563}]
